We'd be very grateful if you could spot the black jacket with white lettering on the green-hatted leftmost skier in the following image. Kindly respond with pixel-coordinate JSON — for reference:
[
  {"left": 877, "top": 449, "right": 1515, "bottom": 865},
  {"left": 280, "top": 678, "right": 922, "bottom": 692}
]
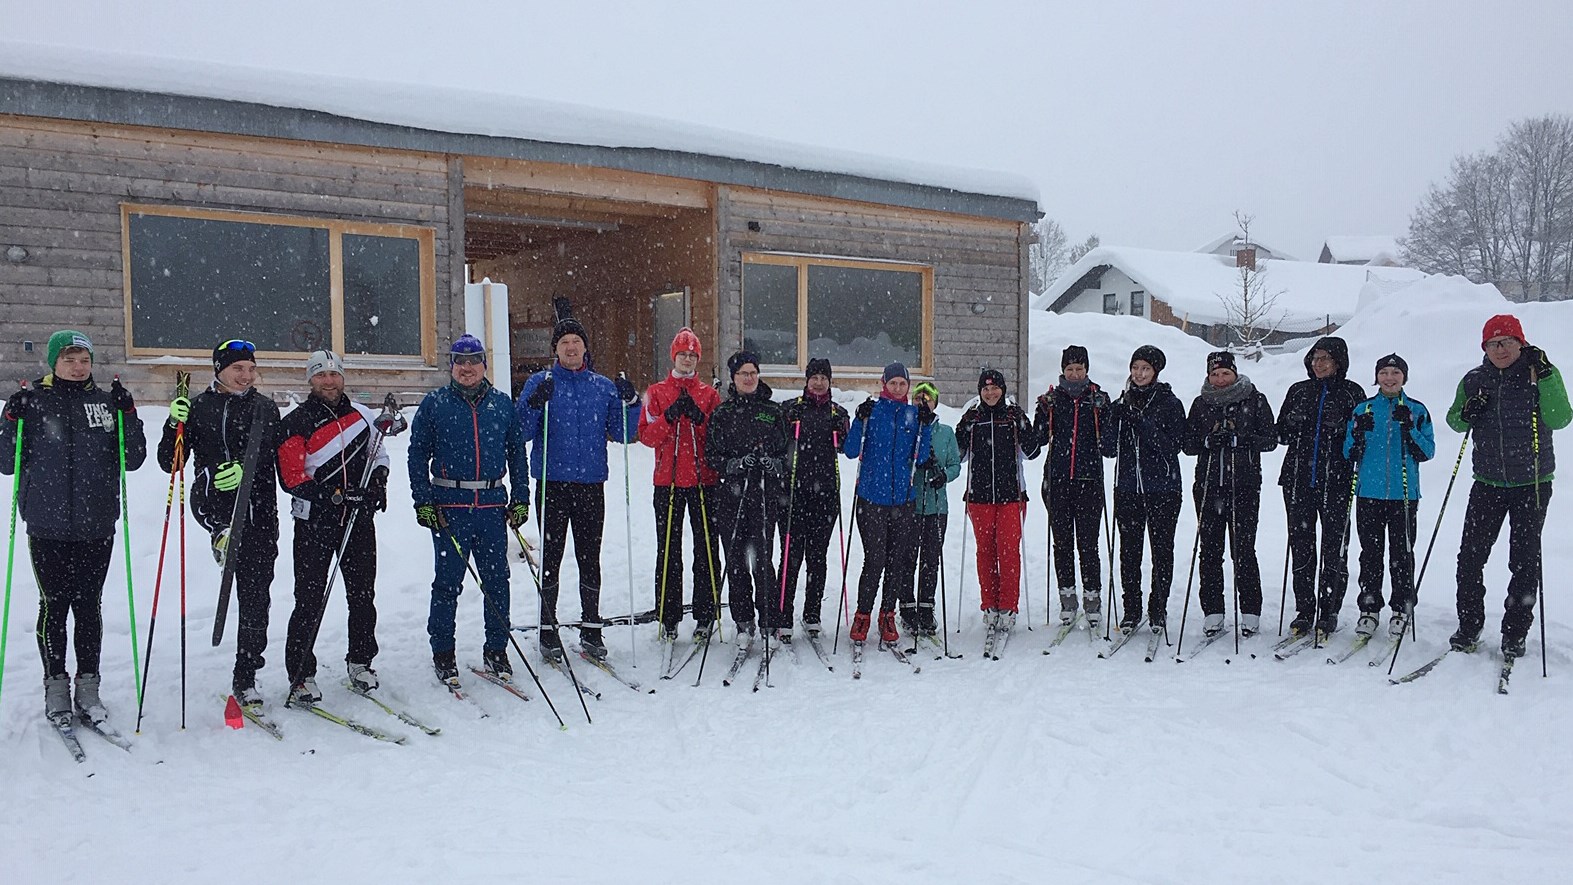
[{"left": 0, "top": 374, "right": 148, "bottom": 541}]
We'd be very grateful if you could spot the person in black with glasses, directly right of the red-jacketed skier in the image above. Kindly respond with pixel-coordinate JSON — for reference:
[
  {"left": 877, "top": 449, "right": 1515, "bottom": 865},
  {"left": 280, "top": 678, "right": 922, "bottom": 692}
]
[{"left": 705, "top": 351, "right": 791, "bottom": 648}]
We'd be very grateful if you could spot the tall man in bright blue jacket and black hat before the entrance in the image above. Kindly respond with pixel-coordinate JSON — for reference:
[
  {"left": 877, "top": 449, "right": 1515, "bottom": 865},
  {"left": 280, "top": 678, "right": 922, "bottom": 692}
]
[{"left": 516, "top": 318, "right": 640, "bottom": 660}]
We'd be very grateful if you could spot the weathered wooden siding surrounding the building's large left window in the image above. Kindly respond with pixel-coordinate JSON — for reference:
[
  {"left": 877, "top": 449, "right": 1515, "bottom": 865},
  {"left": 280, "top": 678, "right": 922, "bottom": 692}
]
[{"left": 0, "top": 115, "right": 464, "bottom": 399}]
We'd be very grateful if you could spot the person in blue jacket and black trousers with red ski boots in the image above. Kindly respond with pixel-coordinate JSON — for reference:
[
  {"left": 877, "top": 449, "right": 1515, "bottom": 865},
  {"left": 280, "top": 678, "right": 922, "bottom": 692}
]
[{"left": 845, "top": 363, "right": 934, "bottom": 643}]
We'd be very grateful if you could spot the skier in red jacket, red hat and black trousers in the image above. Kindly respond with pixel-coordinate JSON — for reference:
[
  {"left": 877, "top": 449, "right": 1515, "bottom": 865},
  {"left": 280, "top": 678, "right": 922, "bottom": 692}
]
[{"left": 639, "top": 327, "right": 722, "bottom": 643}]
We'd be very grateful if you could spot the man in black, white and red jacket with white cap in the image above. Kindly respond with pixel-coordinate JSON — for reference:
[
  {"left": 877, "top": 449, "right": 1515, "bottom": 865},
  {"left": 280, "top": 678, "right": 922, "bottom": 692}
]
[{"left": 278, "top": 351, "right": 389, "bottom": 703}]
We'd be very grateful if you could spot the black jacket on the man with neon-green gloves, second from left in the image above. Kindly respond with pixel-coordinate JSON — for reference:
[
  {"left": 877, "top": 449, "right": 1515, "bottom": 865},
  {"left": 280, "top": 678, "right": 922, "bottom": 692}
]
[{"left": 159, "top": 388, "right": 280, "bottom": 538}]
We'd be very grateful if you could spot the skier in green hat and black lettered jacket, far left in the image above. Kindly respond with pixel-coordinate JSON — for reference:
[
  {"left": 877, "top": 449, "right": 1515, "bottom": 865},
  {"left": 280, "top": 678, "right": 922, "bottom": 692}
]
[{"left": 0, "top": 330, "right": 148, "bottom": 723}]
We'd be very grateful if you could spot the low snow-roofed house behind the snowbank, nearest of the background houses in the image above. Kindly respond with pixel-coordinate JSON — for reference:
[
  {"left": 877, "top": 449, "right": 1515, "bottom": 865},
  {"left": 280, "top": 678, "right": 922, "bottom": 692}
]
[{"left": 1037, "top": 245, "right": 1425, "bottom": 346}]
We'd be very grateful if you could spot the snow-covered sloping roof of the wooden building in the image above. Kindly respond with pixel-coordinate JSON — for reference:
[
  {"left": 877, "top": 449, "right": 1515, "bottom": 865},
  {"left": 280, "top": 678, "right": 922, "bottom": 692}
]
[{"left": 0, "top": 39, "right": 1038, "bottom": 220}]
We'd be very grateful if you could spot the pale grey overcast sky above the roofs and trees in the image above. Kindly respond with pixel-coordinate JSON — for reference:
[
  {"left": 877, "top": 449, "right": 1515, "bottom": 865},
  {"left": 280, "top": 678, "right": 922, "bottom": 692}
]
[{"left": 0, "top": 0, "right": 1573, "bottom": 259}]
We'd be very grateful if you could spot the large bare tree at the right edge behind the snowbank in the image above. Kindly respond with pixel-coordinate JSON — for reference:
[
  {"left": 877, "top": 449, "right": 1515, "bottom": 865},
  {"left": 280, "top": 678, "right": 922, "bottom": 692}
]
[{"left": 1403, "top": 116, "right": 1573, "bottom": 300}]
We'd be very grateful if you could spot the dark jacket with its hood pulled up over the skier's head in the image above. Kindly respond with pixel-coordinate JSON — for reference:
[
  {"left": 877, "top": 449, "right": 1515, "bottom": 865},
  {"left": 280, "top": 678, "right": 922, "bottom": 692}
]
[{"left": 1277, "top": 335, "right": 1365, "bottom": 494}]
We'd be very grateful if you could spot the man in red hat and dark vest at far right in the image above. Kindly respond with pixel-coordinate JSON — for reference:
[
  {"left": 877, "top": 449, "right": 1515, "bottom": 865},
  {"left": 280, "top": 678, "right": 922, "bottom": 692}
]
[{"left": 1447, "top": 314, "right": 1573, "bottom": 659}]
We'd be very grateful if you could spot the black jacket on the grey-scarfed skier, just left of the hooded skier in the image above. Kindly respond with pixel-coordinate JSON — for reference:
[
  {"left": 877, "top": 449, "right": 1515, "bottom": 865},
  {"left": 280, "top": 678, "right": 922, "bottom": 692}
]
[{"left": 1184, "top": 376, "right": 1277, "bottom": 495}]
